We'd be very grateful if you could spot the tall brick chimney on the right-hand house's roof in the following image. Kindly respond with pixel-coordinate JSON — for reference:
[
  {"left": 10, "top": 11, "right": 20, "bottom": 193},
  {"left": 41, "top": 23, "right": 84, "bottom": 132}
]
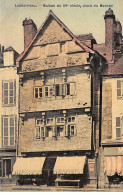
[{"left": 104, "top": 8, "right": 115, "bottom": 62}]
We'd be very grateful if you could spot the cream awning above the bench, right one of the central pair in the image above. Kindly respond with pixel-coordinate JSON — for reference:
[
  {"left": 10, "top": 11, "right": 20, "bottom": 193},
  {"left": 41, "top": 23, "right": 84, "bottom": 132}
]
[{"left": 54, "top": 156, "right": 86, "bottom": 174}]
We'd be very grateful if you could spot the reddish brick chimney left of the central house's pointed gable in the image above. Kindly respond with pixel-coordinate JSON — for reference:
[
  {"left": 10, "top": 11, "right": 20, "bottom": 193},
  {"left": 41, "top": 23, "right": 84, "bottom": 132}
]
[{"left": 23, "top": 19, "right": 37, "bottom": 49}]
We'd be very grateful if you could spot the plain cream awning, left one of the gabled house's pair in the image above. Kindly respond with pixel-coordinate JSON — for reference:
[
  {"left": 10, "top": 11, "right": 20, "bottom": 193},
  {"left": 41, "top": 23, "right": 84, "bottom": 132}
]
[{"left": 12, "top": 157, "right": 45, "bottom": 175}]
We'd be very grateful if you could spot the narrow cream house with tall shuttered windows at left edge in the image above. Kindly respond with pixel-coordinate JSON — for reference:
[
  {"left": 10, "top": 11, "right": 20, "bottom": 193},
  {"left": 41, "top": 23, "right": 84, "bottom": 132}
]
[{"left": 0, "top": 46, "right": 19, "bottom": 183}]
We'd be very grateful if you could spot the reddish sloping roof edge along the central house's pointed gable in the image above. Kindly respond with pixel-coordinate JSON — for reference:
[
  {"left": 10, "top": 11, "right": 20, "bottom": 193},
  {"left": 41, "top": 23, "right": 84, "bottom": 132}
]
[{"left": 16, "top": 10, "right": 95, "bottom": 66}]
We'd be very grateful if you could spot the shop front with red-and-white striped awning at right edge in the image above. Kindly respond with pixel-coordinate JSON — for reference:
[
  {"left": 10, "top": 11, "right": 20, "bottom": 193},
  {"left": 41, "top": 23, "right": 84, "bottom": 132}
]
[{"left": 104, "top": 146, "right": 123, "bottom": 189}]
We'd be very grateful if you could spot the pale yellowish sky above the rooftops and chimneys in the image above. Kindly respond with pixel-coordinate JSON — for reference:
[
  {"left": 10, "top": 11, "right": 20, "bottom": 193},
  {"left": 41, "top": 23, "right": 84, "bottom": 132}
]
[{"left": 0, "top": 0, "right": 123, "bottom": 53}]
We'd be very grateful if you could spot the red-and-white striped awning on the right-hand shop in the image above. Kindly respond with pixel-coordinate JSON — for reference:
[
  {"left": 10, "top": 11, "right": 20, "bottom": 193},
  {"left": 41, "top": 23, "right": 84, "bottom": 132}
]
[{"left": 105, "top": 156, "right": 123, "bottom": 176}]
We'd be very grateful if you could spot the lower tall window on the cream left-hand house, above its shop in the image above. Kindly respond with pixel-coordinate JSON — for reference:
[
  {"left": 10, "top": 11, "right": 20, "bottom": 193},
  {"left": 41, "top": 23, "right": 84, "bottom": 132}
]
[{"left": 2, "top": 116, "right": 16, "bottom": 146}]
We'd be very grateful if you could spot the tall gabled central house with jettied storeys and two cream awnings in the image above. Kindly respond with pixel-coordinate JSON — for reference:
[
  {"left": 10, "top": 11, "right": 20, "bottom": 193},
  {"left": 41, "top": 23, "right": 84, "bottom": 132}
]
[{"left": 13, "top": 11, "right": 103, "bottom": 187}]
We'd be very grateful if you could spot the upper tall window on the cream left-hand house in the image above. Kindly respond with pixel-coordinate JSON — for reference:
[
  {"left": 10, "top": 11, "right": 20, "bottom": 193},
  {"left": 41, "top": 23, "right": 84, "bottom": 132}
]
[{"left": 2, "top": 80, "right": 16, "bottom": 106}]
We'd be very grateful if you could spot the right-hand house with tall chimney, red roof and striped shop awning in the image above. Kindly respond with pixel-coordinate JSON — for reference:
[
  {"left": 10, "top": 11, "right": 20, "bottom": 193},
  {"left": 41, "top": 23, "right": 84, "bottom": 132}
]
[{"left": 94, "top": 9, "right": 123, "bottom": 188}]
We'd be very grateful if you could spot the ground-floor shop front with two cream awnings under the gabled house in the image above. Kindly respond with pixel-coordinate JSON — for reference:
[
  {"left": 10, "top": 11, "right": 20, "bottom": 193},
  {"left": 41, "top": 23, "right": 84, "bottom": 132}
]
[{"left": 12, "top": 155, "right": 97, "bottom": 187}]
